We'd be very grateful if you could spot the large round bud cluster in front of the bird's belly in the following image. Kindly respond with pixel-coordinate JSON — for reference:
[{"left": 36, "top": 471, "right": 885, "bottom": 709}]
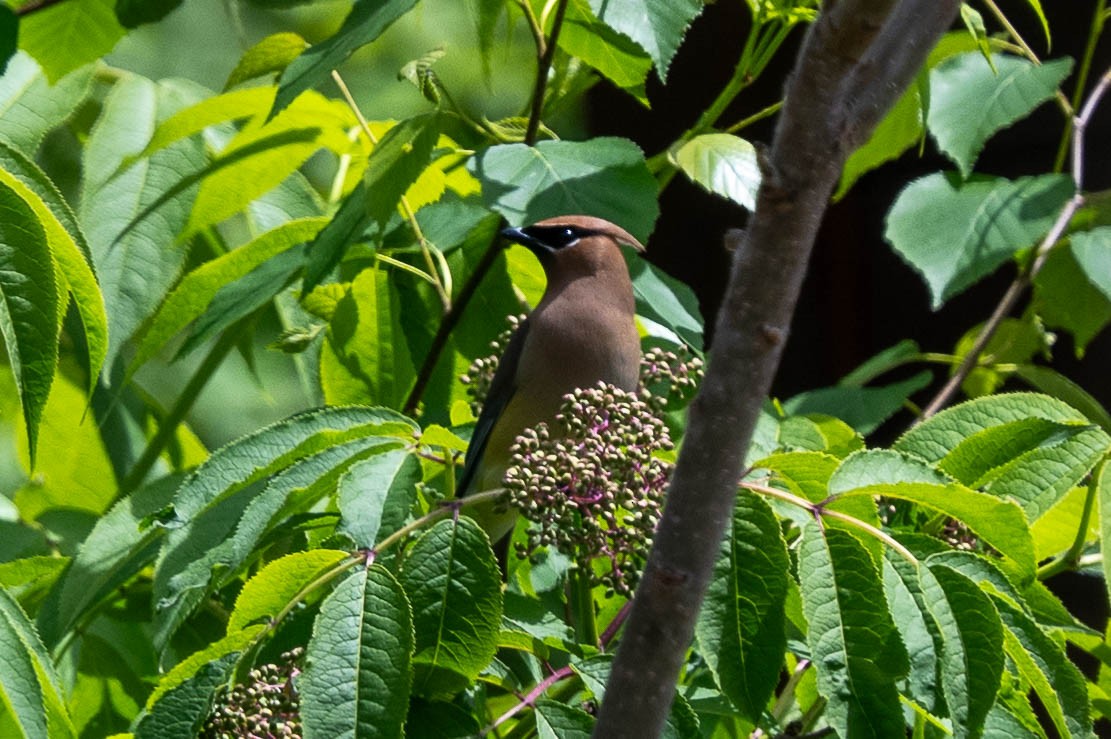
[{"left": 504, "top": 382, "right": 672, "bottom": 595}]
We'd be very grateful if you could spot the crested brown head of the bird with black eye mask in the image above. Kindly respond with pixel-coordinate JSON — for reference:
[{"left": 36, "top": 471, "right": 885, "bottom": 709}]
[{"left": 501, "top": 216, "right": 644, "bottom": 269}]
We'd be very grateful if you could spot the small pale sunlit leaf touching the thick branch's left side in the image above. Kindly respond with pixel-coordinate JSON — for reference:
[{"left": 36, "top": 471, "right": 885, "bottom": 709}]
[{"left": 671, "top": 133, "right": 760, "bottom": 211}]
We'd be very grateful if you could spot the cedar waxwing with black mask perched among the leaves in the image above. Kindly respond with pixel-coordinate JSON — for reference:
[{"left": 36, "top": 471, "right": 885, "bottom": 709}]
[{"left": 459, "top": 216, "right": 644, "bottom": 541}]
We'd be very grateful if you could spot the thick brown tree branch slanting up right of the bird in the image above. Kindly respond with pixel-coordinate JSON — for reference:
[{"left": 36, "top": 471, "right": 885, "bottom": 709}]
[{"left": 594, "top": 0, "right": 959, "bottom": 739}]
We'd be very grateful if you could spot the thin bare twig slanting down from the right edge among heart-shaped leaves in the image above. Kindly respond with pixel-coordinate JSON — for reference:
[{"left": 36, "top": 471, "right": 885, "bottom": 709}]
[{"left": 919, "top": 69, "right": 1111, "bottom": 422}]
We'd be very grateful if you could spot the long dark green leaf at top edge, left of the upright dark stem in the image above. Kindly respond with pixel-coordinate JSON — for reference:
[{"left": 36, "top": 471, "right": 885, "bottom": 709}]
[{"left": 270, "top": 0, "right": 417, "bottom": 118}]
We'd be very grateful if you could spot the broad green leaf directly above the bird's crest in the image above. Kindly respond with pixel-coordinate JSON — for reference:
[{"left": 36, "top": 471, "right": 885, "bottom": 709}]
[{"left": 468, "top": 137, "right": 660, "bottom": 242}]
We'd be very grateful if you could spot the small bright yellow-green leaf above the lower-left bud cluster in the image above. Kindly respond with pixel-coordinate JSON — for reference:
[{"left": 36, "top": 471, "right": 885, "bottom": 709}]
[{"left": 228, "top": 549, "right": 348, "bottom": 633}]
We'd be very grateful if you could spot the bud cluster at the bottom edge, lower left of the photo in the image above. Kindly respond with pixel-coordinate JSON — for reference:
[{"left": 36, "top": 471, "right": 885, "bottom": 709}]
[{"left": 200, "top": 648, "right": 303, "bottom": 739}]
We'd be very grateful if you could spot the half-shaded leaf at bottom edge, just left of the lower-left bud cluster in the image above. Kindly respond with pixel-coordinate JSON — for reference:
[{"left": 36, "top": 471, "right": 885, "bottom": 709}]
[{"left": 134, "top": 626, "right": 264, "bottom": 739}]
